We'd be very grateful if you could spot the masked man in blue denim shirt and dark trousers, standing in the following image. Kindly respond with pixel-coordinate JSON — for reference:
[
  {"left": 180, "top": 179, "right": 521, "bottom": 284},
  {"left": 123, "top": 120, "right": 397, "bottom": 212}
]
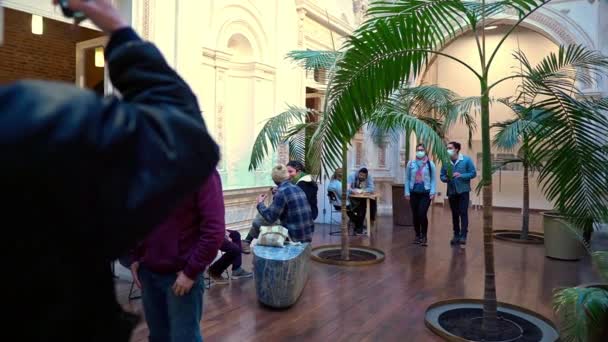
[{"left": 440, "top": 142, "right": 477, "bottom": 245}]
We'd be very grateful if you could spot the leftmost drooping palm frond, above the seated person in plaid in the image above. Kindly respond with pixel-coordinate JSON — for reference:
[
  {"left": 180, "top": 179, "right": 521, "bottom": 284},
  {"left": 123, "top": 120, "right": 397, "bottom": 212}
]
[{"left": 249, "top": 106, "right": 311, "bottom": 171}]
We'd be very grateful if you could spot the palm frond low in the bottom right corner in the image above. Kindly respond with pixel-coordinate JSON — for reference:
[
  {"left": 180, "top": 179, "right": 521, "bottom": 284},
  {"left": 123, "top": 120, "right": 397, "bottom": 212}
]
[{"left": 553, "top": 287, "right": 608, "bottom": 342}]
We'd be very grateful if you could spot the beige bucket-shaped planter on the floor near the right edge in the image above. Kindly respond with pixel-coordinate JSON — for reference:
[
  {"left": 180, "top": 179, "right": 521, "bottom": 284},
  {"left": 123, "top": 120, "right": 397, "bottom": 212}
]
[{"left": 542, "top": 211, "right": 586, "bottom": 260}]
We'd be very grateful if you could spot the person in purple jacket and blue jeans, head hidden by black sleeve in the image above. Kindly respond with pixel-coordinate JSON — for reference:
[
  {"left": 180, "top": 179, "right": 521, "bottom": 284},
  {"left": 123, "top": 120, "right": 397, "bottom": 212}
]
[{"left": 131, "top": 171, "right": 226, "bottom": 342}]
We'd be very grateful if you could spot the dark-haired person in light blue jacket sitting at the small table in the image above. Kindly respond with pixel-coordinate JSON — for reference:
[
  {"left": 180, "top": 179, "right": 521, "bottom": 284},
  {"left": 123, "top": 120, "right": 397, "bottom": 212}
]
[{"left": 348, "top": 168, "right": 377, "bottom": 234}]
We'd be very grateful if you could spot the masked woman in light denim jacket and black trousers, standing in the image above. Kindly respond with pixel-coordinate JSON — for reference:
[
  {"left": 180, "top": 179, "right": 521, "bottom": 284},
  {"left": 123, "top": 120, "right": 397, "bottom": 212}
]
[{"left": 405, "top": 144, "right": 436, "bottom": 246}]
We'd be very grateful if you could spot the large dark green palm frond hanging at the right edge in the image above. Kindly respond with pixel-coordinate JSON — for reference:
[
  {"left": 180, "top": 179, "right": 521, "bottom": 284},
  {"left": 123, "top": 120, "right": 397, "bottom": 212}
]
[{"left": 529, "top": 95, "right": 608, "bottom": 229}]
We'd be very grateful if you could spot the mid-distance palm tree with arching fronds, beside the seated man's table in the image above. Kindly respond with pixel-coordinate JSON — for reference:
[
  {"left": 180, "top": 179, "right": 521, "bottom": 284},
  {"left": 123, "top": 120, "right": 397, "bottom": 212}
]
[{"left": 249, "top": 50, "right": 464, "bottom": 260}]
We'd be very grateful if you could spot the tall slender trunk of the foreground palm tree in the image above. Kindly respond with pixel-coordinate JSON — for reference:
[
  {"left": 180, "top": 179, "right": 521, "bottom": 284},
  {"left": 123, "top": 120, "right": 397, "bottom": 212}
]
[{"left": 481, "top": 87, "right": 498, "bottom": 339}]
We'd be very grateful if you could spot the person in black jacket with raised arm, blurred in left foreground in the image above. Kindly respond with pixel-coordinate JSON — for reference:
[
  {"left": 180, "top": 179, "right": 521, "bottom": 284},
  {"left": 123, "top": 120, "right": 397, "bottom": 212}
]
[{"left": 0, "top": 0, "right": 219, "bottom": 342}]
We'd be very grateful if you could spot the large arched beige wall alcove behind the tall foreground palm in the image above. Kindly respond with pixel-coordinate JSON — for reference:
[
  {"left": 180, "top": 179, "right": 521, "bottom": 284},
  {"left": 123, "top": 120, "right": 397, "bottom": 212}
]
[{"left": 418, "top": 24, "right": 558, "bottom": 209}]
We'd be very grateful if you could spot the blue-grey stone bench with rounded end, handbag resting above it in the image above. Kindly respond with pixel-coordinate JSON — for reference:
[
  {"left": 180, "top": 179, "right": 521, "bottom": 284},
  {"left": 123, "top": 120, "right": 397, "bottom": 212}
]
[{"left": 253, "top": 243, "right": 311, "bottom": 309}]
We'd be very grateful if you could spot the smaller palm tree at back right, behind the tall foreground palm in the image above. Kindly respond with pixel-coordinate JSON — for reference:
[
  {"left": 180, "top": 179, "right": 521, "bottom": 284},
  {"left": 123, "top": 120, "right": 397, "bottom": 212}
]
[{"left": 491, "top": 99, "right": 542, "bottom": 240}]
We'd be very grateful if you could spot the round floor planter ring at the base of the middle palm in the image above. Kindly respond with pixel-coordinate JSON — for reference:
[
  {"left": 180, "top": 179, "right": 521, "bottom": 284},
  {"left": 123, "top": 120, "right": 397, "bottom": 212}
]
[{"left": 311, "top": 245, "right": 384, "bottom": 266}]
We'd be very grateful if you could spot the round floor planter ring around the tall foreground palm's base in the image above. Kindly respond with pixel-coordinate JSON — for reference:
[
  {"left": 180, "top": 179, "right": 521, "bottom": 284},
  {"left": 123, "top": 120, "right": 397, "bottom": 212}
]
[{"left": 424, "top": 299, "right": 559, "bottom": 342}]
